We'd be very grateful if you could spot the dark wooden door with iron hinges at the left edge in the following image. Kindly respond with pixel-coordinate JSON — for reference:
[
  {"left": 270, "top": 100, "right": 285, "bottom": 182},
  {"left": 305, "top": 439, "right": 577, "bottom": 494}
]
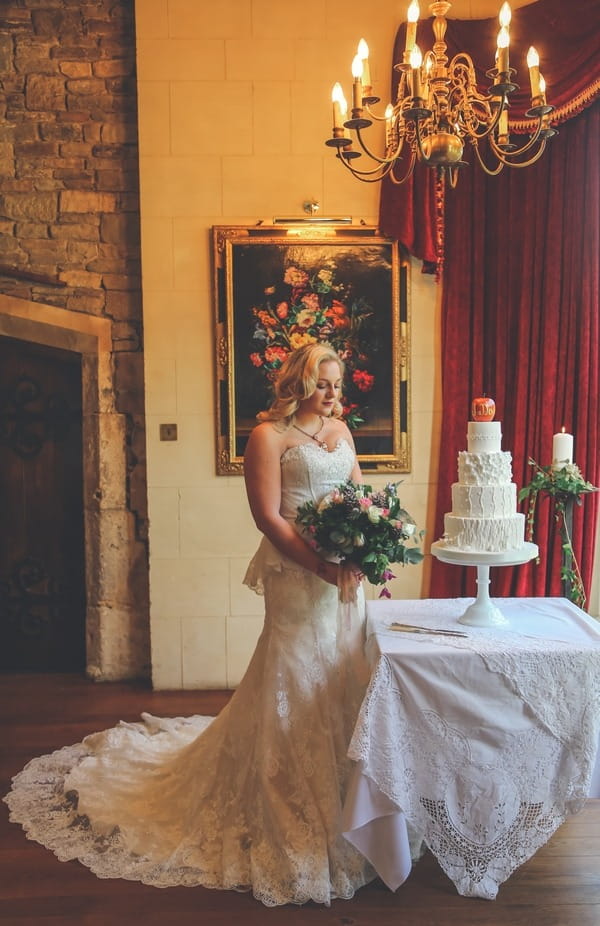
[{"left": 0, "top": 337, "right": 85, "bottom": 672}]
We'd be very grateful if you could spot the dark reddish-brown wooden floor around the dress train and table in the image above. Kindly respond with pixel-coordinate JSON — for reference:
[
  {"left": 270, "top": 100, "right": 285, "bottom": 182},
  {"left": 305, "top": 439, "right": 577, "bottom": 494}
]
[{"left": 0, "top": 675, "right": 600, "bottom": 926}]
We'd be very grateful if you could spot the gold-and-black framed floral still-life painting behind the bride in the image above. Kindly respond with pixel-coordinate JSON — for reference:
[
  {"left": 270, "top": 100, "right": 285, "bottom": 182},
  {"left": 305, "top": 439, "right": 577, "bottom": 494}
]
[{"left": 213, "top": 225, "right": 410, "bottom": 475}]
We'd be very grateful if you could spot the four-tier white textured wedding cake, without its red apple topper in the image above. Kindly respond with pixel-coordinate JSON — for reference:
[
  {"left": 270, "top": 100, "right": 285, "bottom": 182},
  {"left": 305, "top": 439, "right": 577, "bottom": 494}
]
[{"left": 444, "top": 421, "right": 525, "bottom": 553}]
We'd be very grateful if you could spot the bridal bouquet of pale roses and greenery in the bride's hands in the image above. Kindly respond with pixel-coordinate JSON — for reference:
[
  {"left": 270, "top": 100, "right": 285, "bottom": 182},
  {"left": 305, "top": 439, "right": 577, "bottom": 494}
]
[{"left": 296, "top": 480, "right": 423, "bottom": 598}]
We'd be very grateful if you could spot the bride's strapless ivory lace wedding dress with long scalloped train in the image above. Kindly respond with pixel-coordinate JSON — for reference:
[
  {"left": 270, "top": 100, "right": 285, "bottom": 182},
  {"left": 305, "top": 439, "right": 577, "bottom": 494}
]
[{"left": 5, "top": 441, "right": 375, "bottom": 906}]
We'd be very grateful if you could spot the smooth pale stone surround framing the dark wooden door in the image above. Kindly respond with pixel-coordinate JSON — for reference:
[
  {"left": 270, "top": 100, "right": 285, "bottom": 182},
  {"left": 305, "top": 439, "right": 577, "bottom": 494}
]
[{"left": 0, "top": 295, "right": 150, "bottom": 681}]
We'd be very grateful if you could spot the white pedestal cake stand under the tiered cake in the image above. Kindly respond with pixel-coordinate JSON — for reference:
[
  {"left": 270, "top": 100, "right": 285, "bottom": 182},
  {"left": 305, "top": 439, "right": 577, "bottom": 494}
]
[{"left": 431, "top": 540, "right": 538, "bottom": 627}]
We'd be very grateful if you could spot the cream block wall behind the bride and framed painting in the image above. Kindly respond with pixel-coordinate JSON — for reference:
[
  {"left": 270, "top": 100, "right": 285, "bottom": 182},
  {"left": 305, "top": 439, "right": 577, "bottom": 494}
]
[{"left": 136, "top": 0, "right": 596, "bottom": 689}]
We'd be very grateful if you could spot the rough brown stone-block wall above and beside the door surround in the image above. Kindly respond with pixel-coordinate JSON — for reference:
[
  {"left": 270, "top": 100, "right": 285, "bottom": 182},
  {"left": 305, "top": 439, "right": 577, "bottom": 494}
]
[{"left": 0, "top": 0, "right": 149, "bottom": 677}]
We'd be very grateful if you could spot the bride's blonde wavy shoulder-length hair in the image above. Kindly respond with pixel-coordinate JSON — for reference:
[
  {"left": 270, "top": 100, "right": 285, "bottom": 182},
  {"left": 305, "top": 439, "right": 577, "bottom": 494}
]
[{"left": 256, "top": 342, "right": 345, "bottom": 428}]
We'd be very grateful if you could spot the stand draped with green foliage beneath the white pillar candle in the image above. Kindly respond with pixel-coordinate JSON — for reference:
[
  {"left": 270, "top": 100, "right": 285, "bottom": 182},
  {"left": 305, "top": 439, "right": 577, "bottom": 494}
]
[{"left": 519, "top": 459, "right": 598, "bottom": 608}]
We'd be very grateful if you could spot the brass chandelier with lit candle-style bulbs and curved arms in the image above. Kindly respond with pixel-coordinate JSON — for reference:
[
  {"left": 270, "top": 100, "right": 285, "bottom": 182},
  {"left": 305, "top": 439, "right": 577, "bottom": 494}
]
[{"left": 325, "top": 0, "right": 556, "bottom": 187}]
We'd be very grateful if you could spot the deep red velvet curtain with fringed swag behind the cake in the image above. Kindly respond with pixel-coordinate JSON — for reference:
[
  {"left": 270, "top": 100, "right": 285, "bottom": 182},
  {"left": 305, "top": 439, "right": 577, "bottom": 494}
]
[{"left": 381, "top": 0, "right": 600, "bottom": 597}]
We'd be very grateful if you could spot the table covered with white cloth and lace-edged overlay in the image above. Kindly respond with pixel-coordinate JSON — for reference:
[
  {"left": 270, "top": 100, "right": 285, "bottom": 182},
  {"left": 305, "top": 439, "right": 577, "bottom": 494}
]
[{"left": 343, "top": 598, "right": 600, "bottom": 899}]
